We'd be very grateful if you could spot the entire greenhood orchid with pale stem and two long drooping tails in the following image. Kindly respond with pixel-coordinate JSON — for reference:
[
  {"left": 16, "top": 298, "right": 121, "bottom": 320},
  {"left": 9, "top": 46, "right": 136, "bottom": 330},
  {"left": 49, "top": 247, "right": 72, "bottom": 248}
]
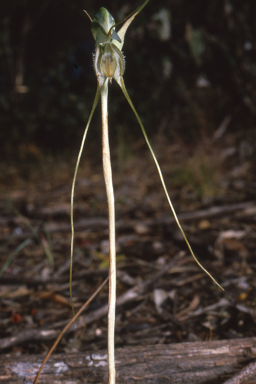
[{"left": 70, "top": 0, "right": 224, "bottom": 384}]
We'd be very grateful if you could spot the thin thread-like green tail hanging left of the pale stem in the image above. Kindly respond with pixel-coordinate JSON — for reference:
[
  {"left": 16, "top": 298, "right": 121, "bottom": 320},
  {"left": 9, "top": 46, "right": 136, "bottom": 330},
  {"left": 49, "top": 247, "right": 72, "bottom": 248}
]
[{"left": 69, "top": 86, "right": 100, "bottom": 316}]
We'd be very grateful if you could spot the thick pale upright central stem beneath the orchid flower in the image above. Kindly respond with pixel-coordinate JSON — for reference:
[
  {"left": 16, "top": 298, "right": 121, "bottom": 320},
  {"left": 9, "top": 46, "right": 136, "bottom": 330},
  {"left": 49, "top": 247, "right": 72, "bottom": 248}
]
[{"left": 101, "top": 79, "right": 116, "bottom": 384}]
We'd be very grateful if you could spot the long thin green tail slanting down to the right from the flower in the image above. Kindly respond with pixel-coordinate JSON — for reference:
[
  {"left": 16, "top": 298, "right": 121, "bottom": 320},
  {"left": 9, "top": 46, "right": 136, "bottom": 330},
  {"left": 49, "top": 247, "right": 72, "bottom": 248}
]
[{"left": 118, "top": 77, "right": 224, "bottom": 291}]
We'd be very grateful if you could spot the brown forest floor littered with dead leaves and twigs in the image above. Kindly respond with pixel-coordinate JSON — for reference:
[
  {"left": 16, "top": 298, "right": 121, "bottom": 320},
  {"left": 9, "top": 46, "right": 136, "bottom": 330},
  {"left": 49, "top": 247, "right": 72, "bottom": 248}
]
[{"left": 0, "top": 134, "right": 256, "bottom": 355}]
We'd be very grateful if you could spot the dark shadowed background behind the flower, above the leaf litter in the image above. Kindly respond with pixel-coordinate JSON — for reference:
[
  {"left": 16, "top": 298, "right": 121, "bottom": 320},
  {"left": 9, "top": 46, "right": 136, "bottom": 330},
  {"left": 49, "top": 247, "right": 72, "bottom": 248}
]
[{"left": 0, "top": 0, "right": 256, "bottom": 162}]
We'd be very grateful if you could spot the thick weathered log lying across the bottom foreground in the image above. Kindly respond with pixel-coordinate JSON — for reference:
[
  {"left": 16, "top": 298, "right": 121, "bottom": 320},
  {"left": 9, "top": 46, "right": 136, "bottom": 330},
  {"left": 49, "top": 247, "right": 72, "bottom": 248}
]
[{"left": 0, "top": 337, "right": 256, "bottom": 384}]
